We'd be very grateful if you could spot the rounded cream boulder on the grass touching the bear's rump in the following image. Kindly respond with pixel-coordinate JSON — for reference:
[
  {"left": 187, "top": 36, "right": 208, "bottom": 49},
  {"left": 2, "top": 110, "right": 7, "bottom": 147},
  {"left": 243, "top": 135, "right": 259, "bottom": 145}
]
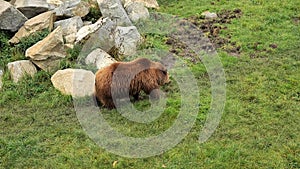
[{"left": 51, "top": 69, "right": 95, "bottom": 97}]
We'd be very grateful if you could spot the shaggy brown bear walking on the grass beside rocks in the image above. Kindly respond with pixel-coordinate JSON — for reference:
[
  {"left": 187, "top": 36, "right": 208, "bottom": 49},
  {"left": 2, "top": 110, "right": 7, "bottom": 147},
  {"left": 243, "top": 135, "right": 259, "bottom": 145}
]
[{"left": 95, "top": 58, "right": 170, "bottom": 108}]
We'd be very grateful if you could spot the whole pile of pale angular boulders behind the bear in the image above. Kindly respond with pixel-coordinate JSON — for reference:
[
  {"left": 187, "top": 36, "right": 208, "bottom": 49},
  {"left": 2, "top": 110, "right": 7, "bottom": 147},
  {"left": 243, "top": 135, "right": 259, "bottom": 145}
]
[{"left": 0, "top": 0, "right": 158, "bottom": 97}]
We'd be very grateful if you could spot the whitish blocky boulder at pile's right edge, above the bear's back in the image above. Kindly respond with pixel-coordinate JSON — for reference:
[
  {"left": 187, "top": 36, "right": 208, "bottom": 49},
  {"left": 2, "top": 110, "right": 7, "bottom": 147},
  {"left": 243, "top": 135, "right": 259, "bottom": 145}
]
[{"left": 115, "top": 26, "right": 141, "bottom": 56}]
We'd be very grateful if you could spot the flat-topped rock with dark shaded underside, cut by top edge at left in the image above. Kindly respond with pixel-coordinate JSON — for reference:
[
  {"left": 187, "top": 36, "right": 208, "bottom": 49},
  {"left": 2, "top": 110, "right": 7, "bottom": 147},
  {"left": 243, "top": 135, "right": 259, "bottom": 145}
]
[{"left": 13, "top": 0, "right": 49, "bottom": 18}]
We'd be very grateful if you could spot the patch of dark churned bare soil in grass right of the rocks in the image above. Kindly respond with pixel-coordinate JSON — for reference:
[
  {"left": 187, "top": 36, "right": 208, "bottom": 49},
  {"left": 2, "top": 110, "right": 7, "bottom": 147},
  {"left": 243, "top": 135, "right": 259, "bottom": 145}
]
[{"left": 166, "top": 9, "right": 242, "bottom": 62}]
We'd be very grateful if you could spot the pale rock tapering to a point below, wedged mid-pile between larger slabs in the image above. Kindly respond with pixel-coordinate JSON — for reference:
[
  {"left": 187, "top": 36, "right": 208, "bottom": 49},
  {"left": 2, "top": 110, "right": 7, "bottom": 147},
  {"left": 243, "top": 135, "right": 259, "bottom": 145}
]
[{"left": 54, "top": 16, "right": 83, "bottom": 44}]
